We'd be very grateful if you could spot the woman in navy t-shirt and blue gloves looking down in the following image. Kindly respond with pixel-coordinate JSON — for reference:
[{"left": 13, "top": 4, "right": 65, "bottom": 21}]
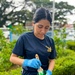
[{"left": 10, "top": 7, "right": 56, "bottom": 75}]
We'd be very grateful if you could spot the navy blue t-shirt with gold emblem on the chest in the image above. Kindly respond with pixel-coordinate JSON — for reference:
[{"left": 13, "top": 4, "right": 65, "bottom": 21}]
[{"left": 13, "top": 32, "right": 56, "bottom": 75}]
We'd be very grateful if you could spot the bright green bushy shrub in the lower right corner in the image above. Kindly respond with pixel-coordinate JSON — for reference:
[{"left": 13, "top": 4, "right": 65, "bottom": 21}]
[{"left": 53, "top": 55, "right": 75, "bottom": 75}]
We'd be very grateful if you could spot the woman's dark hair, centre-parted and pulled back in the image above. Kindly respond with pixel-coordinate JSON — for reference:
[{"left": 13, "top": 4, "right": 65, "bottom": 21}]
[{"left": 33, "top": 7, "right": 52, "bottom": 24}]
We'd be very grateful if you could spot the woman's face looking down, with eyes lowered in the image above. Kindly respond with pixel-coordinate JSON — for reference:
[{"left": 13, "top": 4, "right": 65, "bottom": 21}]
[{"left": 32, "top": 19, "right": 50, "bottom": 39}]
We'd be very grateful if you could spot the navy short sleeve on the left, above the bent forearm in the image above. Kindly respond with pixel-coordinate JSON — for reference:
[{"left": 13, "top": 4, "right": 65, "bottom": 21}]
[{"left": 12, "top": 36, "right": 24, "bottom": 56}]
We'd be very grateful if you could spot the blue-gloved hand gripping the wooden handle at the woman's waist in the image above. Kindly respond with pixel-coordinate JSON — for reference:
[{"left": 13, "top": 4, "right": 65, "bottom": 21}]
[{"left": 22, "top": 58, "right": 42, "bottom": 69}]
